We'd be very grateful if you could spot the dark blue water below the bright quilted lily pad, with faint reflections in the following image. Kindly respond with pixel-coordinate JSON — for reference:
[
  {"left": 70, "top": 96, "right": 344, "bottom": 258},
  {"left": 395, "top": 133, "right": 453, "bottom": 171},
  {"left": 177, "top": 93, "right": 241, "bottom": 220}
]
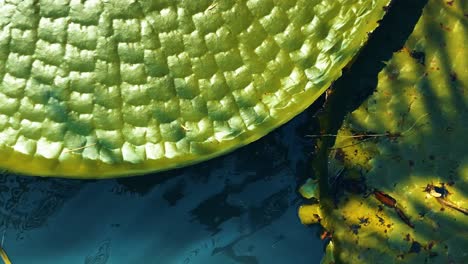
[{"left": 0, "top": 104, "right": 324, "bottom": 264}]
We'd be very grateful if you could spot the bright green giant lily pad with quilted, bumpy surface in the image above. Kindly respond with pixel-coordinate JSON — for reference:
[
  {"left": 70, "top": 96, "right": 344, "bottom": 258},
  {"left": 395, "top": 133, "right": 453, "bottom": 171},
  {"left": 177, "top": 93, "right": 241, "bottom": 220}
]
[{"left": 0, "top": 0, "right": 389, "bottom": 178}]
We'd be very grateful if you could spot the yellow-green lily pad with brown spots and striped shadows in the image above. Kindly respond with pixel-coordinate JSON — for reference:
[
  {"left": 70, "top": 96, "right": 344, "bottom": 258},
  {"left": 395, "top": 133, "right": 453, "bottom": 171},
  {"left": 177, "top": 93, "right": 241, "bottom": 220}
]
[{"left": 304, "top": 0, "right": 468, "bottom": 263}]
